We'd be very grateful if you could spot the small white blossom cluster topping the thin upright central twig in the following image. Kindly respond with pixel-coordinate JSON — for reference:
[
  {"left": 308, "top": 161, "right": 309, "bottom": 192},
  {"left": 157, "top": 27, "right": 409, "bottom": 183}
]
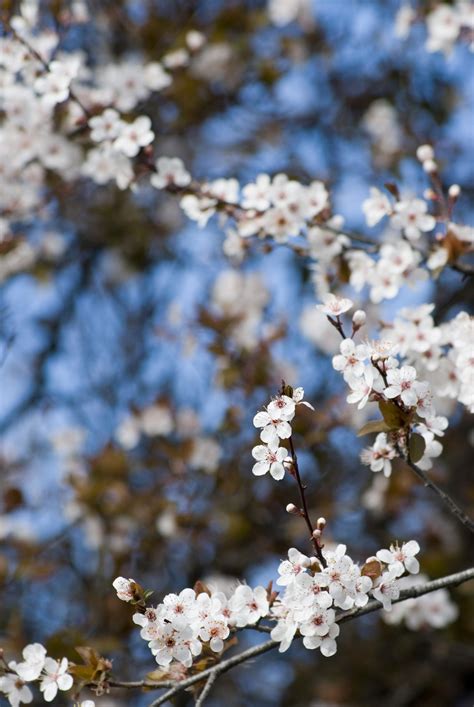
[{"left": 252, "top": 388, "right": 313, "bottom": 481}]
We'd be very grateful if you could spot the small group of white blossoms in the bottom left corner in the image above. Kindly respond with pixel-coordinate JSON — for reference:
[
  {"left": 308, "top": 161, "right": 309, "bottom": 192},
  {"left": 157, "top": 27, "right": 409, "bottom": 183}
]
[{"left": 0, "top": 643, "right": 73, "bottom": 707}]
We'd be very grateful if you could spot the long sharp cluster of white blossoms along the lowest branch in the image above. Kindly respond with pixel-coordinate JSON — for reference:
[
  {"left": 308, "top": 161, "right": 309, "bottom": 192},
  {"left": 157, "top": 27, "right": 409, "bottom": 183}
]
[{"left": 113, "top": 540, "right": 428, "bottom": 668}]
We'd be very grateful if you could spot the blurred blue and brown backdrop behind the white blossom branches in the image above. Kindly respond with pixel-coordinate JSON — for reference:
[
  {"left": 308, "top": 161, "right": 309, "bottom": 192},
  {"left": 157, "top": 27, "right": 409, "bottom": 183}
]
[{"left": 0, "top": 0, "right": 474, "bottom": 707}]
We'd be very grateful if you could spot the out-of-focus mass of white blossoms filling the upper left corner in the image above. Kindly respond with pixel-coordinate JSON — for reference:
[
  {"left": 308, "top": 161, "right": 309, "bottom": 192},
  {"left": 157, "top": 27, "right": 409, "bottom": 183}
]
[{"left": 0, "top": 2, "right": 205, "bottom": 242}]
